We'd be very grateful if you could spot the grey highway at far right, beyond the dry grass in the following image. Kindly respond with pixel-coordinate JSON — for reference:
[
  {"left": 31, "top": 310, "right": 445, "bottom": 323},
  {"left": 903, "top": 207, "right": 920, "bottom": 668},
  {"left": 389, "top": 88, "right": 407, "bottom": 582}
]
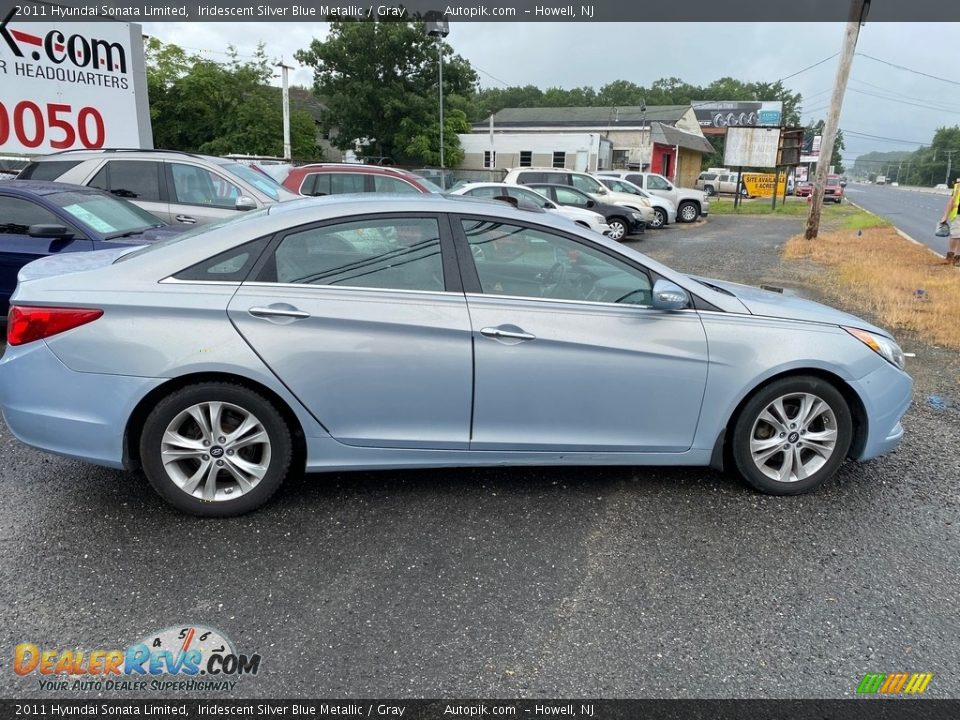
[{"left": 845, "top": 183, "right": 949, "bottom": 255}]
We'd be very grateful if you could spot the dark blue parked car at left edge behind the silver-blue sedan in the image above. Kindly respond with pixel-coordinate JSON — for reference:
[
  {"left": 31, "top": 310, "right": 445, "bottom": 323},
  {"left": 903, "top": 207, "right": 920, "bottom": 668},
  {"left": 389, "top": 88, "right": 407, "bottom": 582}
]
[{"left": 0, "top": 180, "right": 189, "bottom": 316}]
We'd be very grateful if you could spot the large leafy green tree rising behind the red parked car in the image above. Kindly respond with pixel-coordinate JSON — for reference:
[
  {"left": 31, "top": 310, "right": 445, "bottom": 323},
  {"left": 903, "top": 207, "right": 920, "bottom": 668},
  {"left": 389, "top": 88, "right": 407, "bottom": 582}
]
[{"left": 295, "top": 20, "right": 477, "bottom": 162}]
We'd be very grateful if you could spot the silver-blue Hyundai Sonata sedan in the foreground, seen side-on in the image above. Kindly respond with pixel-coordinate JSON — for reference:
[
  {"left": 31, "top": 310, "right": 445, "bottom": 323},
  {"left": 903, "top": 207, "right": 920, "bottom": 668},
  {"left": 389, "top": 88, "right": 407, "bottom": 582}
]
[{"left": 0, "top": 195, "right": 912, "bottom": 516}]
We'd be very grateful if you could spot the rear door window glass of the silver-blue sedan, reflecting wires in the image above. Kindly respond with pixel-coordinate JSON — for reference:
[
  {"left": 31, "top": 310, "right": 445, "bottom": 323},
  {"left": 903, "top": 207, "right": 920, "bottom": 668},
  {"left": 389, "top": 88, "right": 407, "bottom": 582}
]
[{"left": 261, "top": 218, "right": 444, "bottom": 290}]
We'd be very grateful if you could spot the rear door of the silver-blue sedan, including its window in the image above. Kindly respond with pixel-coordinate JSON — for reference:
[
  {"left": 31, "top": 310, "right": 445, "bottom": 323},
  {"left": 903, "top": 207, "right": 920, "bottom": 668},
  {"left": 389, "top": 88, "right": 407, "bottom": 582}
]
[{"left": 228, "top": 214, "right": 473, "bottom": 449}]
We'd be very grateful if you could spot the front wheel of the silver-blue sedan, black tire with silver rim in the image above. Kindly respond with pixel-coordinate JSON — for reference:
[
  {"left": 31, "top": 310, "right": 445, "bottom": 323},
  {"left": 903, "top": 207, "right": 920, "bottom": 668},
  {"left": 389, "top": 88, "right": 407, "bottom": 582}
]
[{"left": 730, "top": 375, "right": 853, "bottom": 495}]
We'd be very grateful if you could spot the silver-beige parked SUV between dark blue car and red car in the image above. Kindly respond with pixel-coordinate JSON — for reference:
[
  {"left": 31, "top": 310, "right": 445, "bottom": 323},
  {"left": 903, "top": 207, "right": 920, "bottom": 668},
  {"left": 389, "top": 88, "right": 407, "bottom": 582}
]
[{"left": 18, "top": 149, "right": 299, "bottom": 225}]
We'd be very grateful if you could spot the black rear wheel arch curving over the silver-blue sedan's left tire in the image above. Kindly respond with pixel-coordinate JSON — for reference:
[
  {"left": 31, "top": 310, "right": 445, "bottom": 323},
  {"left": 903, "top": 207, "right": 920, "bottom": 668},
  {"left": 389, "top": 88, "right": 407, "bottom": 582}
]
[{"left": 123, "top": 372, "right": 307, "bottom": 470}]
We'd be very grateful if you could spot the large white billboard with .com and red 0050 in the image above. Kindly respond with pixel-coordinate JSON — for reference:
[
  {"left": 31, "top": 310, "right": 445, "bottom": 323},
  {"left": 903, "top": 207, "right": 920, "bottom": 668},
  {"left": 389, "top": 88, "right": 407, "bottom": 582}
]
[{"left": 0, "top": 21, "right": 153, "bottom": 155}]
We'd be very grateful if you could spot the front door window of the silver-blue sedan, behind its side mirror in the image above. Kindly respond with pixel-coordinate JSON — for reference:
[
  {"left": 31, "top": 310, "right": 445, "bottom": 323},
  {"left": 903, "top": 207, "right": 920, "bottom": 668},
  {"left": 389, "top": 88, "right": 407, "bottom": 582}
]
[{"left": 462, "top": 219, "right": 653, "bottom": 305}]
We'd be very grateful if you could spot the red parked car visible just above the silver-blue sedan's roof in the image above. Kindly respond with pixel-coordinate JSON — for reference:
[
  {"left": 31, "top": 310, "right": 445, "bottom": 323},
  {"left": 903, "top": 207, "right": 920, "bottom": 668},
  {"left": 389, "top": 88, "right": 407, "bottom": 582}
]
[{"left": 283, "top": 163, "right": 442, "bottom": 196}]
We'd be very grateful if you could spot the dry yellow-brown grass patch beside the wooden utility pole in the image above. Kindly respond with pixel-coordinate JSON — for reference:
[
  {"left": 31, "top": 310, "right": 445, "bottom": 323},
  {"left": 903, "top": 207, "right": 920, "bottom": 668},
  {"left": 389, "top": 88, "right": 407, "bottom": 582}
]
[{"left": 783, "top": 226, "right": 960, "bottom": 348}]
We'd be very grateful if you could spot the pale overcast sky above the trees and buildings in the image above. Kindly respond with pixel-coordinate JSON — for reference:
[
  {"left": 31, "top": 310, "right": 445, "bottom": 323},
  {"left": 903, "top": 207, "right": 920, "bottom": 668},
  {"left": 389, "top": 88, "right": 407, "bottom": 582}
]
[{"left": 144, "top": 21, "right": 960, "bottom": 161}]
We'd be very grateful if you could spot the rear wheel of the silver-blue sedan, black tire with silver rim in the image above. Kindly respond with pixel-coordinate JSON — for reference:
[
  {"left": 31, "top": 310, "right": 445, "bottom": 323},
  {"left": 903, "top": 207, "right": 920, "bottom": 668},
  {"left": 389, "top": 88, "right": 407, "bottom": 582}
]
[{"left": 140, "top": 382, "right": 293, "bottom": 517}]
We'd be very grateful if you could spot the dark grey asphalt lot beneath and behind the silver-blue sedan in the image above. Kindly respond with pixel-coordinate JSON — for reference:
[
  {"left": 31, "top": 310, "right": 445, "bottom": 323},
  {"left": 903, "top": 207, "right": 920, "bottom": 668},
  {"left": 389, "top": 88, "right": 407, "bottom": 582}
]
[{"left": 0, "top": 217, "right": 960, "bottom": 698}]
